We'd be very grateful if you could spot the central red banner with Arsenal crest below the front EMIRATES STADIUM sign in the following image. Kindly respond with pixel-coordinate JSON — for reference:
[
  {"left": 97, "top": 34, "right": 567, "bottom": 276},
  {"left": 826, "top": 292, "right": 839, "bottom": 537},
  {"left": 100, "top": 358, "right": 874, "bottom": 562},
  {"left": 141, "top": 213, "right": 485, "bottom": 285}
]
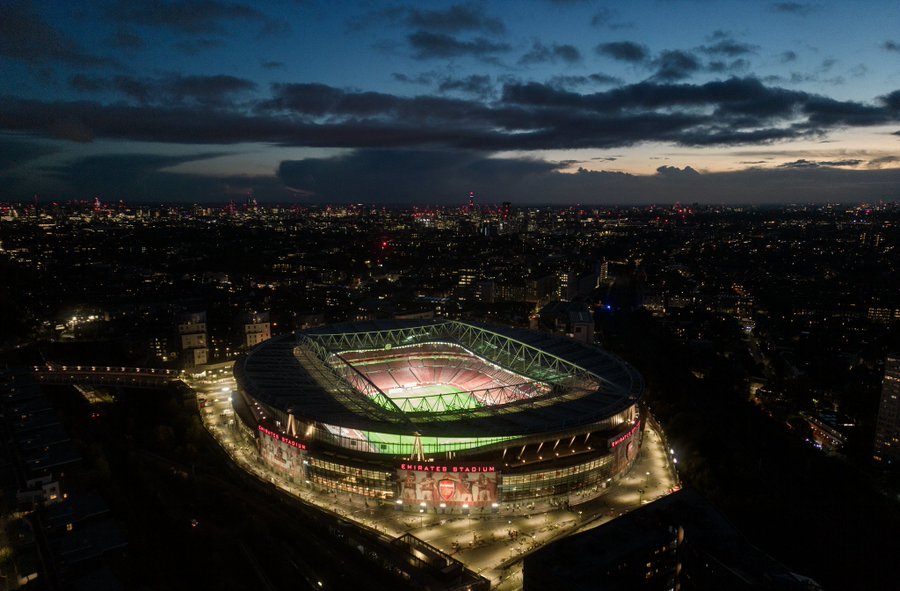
[{"left": 396, "top": 462, "right": 500, "bottom": 507}]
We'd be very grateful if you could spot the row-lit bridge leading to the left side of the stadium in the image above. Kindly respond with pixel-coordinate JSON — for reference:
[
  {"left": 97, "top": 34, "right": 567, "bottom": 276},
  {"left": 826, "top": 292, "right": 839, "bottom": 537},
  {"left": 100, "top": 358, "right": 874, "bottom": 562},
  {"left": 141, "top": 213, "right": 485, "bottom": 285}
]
[{"left": 31, "top": 363, "right": 184, "bottom": 388}]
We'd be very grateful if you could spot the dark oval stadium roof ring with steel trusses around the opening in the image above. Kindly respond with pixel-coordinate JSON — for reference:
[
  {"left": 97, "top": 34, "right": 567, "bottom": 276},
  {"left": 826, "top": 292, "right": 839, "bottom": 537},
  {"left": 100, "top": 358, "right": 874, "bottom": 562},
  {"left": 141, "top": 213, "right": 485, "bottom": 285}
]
[{"left": 235, "top": 320, "right": 643, "bottom": 437}]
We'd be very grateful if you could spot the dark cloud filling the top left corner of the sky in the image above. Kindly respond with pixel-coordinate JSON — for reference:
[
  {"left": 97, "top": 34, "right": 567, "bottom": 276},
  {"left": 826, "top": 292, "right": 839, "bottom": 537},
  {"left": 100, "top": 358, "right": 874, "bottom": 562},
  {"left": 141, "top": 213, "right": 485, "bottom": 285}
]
[{"left": 0, "top": 2, "right": 118, "bottom": 67}]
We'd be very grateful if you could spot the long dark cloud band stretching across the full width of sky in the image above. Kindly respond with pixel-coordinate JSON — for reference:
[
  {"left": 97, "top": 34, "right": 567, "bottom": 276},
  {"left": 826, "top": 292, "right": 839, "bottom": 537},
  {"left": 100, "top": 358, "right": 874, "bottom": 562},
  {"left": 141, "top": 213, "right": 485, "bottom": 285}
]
[{"left": 0, "top": 76, "right": 900, "bottom": 151}]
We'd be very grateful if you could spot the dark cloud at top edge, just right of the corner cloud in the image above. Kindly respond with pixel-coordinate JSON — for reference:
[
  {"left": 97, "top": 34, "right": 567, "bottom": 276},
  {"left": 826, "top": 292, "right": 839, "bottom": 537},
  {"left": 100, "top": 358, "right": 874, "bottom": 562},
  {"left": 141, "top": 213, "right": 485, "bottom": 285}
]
[{"left": 107, "top": 0, "right": 267, "bottom": 34}]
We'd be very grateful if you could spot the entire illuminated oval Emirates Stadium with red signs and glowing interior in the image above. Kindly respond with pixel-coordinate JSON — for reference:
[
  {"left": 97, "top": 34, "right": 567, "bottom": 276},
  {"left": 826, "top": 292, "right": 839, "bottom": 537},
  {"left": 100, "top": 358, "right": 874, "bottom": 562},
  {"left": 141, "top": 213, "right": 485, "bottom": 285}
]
[{"left": 234, "top": 320, "right": 643, "bottom": 513}]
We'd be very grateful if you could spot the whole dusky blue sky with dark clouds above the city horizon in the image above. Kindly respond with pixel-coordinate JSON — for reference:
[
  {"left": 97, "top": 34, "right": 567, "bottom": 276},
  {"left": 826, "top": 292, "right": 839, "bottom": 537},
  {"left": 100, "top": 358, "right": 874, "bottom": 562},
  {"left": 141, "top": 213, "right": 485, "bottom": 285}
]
[{"left": 0, "top": 0, "right": 900, "bottom": 204}]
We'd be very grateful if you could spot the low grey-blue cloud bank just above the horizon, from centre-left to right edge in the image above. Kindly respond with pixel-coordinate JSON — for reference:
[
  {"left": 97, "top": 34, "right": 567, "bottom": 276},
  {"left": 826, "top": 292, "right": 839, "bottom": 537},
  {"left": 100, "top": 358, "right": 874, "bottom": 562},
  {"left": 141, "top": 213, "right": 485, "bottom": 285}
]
[{"left": 278, "top": 150, "right": 900, "bottom": 204}]
